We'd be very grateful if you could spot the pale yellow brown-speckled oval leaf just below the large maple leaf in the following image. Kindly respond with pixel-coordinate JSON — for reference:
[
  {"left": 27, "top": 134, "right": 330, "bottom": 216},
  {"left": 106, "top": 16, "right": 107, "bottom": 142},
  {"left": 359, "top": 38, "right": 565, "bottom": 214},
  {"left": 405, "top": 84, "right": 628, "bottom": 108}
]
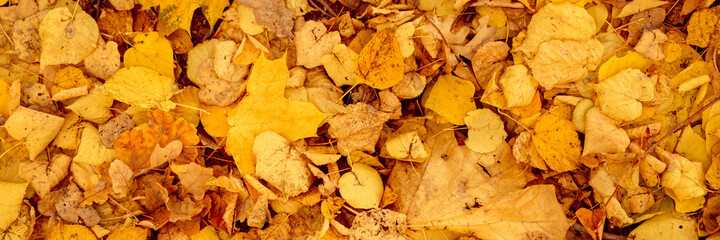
[{"left": 252, "top": 132, "right": 312, "bottom": 197}]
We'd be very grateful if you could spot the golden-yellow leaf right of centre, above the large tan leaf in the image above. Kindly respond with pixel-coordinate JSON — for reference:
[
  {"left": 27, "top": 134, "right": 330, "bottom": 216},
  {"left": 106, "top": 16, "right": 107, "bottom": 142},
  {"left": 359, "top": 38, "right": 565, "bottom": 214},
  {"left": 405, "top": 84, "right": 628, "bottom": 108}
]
[{"left": 423, "top": 75, "right": 477, "bottom": 125}]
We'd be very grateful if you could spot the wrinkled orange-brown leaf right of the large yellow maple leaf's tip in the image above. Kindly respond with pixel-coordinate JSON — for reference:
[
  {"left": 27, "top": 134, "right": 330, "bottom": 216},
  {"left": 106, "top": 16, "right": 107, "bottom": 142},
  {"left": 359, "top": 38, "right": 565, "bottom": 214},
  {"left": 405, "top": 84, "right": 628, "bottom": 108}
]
[{"left": 328, "top": 103, "right": 390, "bottom": 155}]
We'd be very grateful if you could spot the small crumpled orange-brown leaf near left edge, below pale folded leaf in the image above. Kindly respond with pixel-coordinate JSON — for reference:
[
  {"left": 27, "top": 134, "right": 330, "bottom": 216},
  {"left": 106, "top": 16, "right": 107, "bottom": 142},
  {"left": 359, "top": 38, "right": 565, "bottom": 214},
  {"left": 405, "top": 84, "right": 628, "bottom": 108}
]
[{"left": 17, "top": 154, "right": 72, "bottom": 198}]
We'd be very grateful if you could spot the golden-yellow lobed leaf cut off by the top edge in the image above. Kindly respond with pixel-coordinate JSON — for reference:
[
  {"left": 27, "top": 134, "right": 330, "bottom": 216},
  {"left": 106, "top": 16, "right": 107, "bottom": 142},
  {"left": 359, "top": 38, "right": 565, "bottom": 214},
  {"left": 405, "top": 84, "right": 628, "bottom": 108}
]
[{"left": 158, "top": 0, "right": 230, "bottom": 36}]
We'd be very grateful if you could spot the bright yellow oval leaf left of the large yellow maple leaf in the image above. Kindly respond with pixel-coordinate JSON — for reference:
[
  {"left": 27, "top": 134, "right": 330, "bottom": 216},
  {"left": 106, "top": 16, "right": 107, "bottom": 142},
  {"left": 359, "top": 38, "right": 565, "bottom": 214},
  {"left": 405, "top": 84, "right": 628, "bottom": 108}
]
[{"left": 105, "top": 67, "right": 178, "bottom": 111}]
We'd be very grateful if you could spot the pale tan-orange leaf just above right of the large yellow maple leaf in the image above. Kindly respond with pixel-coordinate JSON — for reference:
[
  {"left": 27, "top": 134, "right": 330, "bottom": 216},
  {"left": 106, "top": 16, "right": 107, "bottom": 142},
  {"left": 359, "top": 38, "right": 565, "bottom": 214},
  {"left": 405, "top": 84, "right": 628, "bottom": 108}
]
[{"left": 294, "top": 21, "right": 340, "bottom": 68}]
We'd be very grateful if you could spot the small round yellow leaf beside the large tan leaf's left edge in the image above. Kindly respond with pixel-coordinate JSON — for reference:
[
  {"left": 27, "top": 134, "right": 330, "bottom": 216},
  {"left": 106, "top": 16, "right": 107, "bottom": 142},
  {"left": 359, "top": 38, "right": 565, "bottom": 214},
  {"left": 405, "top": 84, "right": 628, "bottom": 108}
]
[{"left": 338, "top": 163, "right": 383, "bottom": 209}]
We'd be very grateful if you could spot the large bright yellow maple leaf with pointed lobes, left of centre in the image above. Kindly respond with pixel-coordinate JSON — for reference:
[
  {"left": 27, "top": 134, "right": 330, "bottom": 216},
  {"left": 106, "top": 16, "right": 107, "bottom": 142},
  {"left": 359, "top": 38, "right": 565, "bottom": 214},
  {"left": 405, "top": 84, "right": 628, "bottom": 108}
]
[{"left": 227, "top": 55, "right": 329, "bottom": 173}]
